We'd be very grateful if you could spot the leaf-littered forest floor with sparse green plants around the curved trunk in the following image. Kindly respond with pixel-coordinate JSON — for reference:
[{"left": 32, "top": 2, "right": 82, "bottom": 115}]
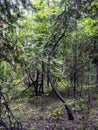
[{"left": 11, "top": 86, "right": 98, "bottom": 130}]
